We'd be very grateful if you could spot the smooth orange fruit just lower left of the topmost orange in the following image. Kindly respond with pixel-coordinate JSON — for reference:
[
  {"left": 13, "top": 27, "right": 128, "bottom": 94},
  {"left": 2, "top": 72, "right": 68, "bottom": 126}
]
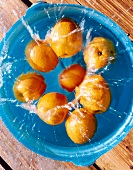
[{"left": 25, "top": 40, "right": 58, "bottom": 72}]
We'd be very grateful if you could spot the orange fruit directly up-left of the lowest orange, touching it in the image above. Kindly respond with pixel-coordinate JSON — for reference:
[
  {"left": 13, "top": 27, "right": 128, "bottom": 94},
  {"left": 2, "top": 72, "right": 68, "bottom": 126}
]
[{"left": 37, "top": 92, "right": 68, "bottom": 125}]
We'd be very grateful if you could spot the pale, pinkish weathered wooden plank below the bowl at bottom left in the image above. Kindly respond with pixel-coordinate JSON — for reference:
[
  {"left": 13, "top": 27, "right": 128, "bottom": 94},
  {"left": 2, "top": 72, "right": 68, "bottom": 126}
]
[{"left": 0, "top": 120, "right": 96, "bottom": 170}]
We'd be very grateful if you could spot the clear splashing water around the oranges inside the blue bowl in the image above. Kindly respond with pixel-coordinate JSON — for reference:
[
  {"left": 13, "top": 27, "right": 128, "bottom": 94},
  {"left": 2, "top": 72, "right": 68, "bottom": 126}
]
[{"left": 0, "top": 2, "right": 133, "bottom": 165}]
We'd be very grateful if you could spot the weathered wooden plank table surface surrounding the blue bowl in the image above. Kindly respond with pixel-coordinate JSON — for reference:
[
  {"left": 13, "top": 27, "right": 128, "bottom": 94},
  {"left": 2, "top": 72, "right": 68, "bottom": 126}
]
[{"left": 0, "top": 0, "right": 133, "bottom": 170}]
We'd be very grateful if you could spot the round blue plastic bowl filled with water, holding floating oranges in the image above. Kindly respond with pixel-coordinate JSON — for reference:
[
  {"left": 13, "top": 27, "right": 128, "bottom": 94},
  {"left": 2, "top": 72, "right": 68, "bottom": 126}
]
[{"left": 0, "top": 3, "right": 133, "bottom": 166}]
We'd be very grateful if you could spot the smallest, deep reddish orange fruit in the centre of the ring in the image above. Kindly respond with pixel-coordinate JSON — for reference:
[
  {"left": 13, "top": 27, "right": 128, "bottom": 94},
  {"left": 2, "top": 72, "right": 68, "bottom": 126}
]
[{"left": 59, "top": 64, "right": 86, "bottom": 92}]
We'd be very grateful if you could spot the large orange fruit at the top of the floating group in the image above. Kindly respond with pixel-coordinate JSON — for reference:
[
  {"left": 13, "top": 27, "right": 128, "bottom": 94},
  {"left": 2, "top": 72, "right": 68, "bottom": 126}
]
[{"left": 47, "top": 18, "right": 83, "bottom": 58}]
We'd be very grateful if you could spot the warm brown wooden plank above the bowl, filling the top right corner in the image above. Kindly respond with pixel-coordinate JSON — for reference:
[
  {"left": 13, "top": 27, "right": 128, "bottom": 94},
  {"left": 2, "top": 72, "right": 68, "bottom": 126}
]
[{"left": 31, "top": 0, "right": 133, "bottom": 41}]
